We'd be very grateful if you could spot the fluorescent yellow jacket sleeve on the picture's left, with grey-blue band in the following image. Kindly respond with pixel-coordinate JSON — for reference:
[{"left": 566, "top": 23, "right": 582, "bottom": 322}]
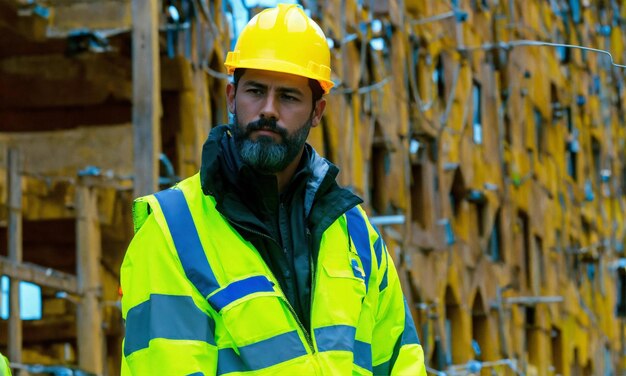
[{"left": 121, "top": 214, "right": 217, "bottom": 375}]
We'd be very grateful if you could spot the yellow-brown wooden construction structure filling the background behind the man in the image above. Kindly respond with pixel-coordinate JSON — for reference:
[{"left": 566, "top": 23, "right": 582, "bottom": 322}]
[{"left": 0, "top": 0, "right": 626, "bottom": 376}]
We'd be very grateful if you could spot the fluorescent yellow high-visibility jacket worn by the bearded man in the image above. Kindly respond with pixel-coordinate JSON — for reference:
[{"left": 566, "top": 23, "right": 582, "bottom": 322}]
[{"left": 121, "top": 175, "right": 426, "bottom": 376}]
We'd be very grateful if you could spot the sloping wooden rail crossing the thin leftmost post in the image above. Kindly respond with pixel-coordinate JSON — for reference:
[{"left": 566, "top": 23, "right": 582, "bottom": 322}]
[{"left": 0, "top": 256, "right": 78, "bottom": 294}]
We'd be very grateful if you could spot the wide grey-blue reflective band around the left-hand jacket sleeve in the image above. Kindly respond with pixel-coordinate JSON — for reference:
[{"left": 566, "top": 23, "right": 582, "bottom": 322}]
[{"left": 124, "top": 294, "right": 215, "bottom": 356}]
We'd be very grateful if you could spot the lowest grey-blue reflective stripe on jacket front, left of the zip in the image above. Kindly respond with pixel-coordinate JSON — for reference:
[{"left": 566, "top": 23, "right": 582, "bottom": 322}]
[{"left": 217, "top": 330, "right": 307, "bottom": 375}]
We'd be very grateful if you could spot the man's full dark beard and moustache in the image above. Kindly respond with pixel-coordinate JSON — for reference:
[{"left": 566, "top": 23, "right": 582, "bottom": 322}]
[{"left": 232, "top": 114, "right": 312, "bottom": 174}]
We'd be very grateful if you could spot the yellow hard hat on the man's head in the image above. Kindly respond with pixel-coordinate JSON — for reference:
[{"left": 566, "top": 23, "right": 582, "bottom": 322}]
[{"left": 224, "top": 4, "right": 334, "bottom": 94}]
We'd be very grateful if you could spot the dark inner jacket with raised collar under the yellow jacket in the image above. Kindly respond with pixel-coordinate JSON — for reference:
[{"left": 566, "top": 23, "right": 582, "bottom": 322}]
[{"left": 200, "top": 125, "right": 362, "bottom": 330}]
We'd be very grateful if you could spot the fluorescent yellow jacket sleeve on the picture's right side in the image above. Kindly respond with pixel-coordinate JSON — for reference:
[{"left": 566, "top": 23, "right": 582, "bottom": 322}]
[{"left": 372, "top": 231, "right": 426, "bottom": 376}]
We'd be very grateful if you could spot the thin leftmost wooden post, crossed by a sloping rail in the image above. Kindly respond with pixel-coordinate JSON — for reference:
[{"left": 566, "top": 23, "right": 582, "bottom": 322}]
[{"left": 7, "top": 148, "right": 22, "bottom": 363}]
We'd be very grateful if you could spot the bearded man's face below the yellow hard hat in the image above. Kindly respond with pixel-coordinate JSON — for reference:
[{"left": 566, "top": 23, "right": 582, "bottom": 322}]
[{"left": 227, "top": 69, "right": 325, "bottom": 174}]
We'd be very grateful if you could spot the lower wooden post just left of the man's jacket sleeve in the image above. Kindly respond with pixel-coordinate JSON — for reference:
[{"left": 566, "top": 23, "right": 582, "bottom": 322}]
[{"left": 76, "top": 182, "right": 104, "bottom": 375}]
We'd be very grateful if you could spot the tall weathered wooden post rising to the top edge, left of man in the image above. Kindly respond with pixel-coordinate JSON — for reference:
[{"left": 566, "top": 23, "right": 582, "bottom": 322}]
[{"left": 132, "top": 0, "right": 161, "bottom": 197}]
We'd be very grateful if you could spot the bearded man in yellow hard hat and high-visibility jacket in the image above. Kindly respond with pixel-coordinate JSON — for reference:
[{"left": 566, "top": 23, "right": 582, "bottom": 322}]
[{"left": 121, "top": 4, "right": 425, "bottom": 375}]
